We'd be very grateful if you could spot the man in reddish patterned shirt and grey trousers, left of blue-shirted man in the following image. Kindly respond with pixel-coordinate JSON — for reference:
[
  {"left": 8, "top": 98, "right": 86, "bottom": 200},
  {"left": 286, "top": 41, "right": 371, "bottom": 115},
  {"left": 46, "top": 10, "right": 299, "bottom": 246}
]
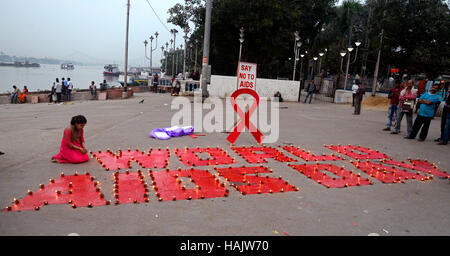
[{"left": 391, "top": 80, "right": 417, "bottom": 136}]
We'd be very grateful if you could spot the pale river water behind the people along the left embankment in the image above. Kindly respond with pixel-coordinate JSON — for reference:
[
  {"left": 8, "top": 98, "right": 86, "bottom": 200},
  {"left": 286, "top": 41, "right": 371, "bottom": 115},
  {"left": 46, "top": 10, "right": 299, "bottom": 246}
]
[{"left": 0, "top": 64, "right": 120, "bottom": 93}]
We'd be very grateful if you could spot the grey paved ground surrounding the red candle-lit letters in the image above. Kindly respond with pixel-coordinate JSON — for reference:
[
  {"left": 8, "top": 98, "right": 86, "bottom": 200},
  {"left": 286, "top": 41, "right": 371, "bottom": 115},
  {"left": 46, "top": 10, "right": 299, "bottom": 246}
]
[{"left": 0, "top": 93, "right": 450, "bottom": 236}]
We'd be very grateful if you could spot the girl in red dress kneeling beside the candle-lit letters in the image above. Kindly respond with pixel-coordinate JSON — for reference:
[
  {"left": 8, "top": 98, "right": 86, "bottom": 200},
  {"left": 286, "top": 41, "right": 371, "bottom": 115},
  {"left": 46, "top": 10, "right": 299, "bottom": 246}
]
[{"left": 52, "top": 115, "right": 89, "bottom": 164}]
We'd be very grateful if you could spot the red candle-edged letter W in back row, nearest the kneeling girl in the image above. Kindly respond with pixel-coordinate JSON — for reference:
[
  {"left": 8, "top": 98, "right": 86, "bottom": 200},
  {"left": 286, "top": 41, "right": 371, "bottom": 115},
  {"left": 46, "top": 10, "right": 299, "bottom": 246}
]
[{"left": 91, "top": 148, "right": 170, "bottom": 171}]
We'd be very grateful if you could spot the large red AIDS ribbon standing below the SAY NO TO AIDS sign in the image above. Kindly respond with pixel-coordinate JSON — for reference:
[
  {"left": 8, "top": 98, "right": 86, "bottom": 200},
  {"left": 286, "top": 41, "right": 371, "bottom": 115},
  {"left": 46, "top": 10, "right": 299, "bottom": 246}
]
[{"left": 227, "top": 89, "right": 264, "bottom": 144}]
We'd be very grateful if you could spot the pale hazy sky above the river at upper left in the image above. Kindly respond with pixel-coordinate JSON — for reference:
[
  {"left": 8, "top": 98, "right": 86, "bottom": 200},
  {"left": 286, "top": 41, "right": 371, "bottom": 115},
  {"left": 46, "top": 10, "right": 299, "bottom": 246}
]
[{"left": 0, "top": 0, "right": 184, "bottom": 66}]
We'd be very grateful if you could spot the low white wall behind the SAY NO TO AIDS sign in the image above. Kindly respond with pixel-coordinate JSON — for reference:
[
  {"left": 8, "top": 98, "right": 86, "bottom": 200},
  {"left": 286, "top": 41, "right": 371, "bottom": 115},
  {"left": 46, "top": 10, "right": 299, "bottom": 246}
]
[{"left": 208, "top": 75, "right": 300, "bottom": 101}]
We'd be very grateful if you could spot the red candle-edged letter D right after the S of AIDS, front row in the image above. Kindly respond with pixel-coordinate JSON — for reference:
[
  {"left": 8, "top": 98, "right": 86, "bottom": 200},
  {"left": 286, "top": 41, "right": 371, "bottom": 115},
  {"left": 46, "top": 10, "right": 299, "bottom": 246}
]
[{"left": 289, "top": 164, "right": 372, "bottom": 188}]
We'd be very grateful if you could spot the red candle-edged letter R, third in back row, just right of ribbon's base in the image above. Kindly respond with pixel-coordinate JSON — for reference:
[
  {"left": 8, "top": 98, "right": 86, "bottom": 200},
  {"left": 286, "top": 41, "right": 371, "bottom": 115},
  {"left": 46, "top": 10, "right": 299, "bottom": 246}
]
[{"left": 232, "top": 146, "right": 296, "bottom": 164}]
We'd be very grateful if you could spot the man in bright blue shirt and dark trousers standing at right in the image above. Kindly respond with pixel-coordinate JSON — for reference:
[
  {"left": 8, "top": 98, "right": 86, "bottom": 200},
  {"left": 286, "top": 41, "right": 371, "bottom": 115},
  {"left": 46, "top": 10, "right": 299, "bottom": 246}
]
[{"left": 407, "top": 84, "right": 439, "bottom": 141}]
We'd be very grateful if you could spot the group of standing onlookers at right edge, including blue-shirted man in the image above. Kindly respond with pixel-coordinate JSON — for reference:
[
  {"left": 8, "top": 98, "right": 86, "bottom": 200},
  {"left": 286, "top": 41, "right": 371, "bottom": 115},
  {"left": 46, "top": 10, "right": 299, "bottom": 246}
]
[{"left": 383, "top": 77, "right": 450, "bottom": 145}]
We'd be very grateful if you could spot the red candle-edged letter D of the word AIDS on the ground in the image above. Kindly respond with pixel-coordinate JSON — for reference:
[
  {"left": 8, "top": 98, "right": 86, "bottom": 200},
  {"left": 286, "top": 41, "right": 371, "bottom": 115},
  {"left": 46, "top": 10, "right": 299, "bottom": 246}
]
[{"left": 149, "top": 169, "right": 229, "bottom": 201}]
